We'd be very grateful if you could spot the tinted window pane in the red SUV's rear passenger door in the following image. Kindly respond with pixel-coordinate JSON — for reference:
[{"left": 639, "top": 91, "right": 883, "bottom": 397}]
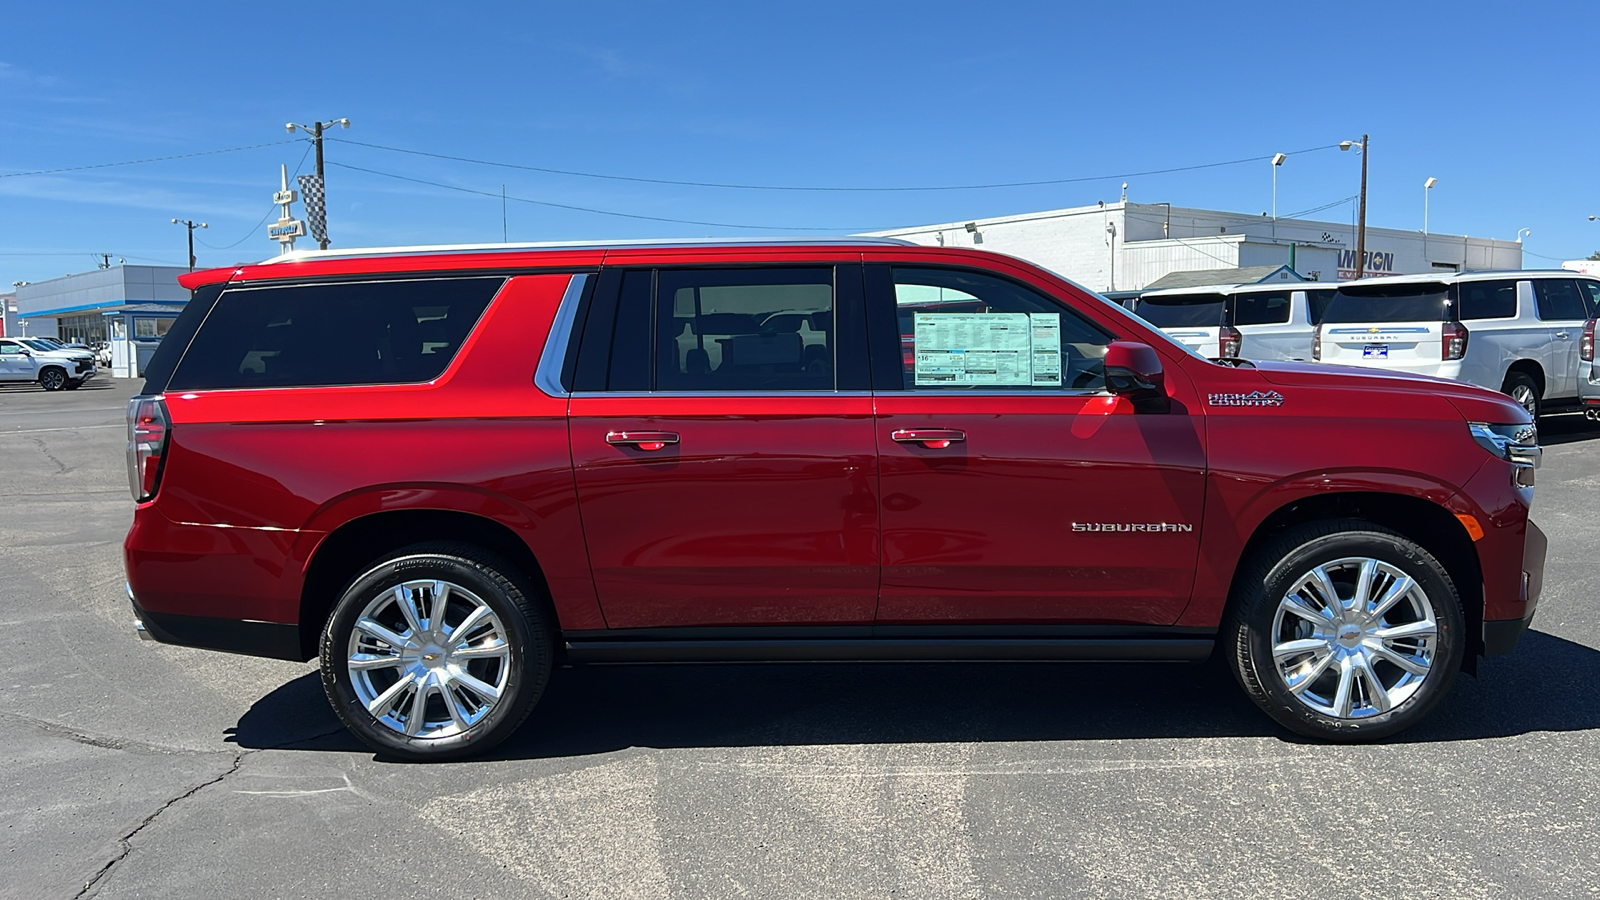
[{"left": 652, "top": 267, "right": 834, "bottom": 391}]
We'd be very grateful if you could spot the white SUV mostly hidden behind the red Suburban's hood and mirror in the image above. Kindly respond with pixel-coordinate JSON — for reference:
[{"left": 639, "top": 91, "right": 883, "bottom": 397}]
[{"left": 1133, "top": 282, "right": 1336, "bottom": 360}]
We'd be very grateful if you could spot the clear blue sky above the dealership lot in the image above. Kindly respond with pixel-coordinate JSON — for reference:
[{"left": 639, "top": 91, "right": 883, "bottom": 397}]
[{"left": 0, "top": 0, "right": 1600, "bottom": 285}]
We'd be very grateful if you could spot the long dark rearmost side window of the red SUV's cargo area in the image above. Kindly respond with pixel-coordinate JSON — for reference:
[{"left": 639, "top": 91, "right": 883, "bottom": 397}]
[{"left": 168, "top": 277, "right": 506, "bottom": 391}]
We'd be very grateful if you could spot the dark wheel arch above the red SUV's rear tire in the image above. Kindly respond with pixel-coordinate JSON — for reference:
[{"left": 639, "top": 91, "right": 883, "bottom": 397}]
[{"left": 299, "top": 509, "right": 560, "bottom": 660}]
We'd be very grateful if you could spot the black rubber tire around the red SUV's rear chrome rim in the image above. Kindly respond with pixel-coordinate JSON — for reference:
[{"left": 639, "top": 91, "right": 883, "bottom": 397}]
[{"left": 320, "top": 543, "right": 555, "bottom": 762}]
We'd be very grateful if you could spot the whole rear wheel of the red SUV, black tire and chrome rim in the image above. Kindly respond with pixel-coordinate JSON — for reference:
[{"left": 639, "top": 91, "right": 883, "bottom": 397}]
[{"left": 322, "top": 543, "right": 554, "bottom": 761}]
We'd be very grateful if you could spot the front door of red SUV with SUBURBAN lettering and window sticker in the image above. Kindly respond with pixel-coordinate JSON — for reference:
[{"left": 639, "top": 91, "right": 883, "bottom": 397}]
[{"left": 867, "top": 266, "right": 1205, "bottom": 625}]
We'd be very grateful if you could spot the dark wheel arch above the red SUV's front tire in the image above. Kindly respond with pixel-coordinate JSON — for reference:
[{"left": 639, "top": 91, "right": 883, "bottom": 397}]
[{"left": 1227, "top": 492, "right": 1483, "bottom": 673}]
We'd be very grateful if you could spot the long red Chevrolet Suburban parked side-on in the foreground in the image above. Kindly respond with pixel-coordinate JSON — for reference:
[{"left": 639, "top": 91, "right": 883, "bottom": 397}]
[{"left": 125, "top": 240, "right": 1544, "bottom": 759}]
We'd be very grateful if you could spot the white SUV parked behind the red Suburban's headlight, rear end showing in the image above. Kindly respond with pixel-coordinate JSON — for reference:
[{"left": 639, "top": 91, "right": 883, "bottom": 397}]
[{"left": 1312, "top": 269, "right": 1600, "bottom": 416}]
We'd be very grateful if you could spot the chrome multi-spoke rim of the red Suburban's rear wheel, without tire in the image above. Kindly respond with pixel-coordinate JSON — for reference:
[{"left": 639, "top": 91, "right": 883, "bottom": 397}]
[{"left": 346, "top": 580, "right": 510, "bottom": 738}]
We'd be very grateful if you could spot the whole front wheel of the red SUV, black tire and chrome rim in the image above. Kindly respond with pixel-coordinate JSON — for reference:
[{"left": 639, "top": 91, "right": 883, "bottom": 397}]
[{"left": 1224, "top": 520, "right": 1466, "bottom": 741}]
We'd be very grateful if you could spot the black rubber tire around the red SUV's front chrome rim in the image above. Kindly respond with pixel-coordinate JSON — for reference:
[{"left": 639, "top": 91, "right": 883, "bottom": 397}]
[{"left": 1219, "top": 519, "right": 1466, "bottom": 741}]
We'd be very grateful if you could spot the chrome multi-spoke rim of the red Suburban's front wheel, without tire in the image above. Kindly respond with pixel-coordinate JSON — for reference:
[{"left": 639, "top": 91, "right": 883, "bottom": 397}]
[{"left": 1272, "top": 557, "right": 1438, "bottom": 719}]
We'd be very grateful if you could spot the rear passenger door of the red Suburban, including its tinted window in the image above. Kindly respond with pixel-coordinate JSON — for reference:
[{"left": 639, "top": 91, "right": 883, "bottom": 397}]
[{"left": 570, "top": 264, "right": 878, "bottom": 628}]
